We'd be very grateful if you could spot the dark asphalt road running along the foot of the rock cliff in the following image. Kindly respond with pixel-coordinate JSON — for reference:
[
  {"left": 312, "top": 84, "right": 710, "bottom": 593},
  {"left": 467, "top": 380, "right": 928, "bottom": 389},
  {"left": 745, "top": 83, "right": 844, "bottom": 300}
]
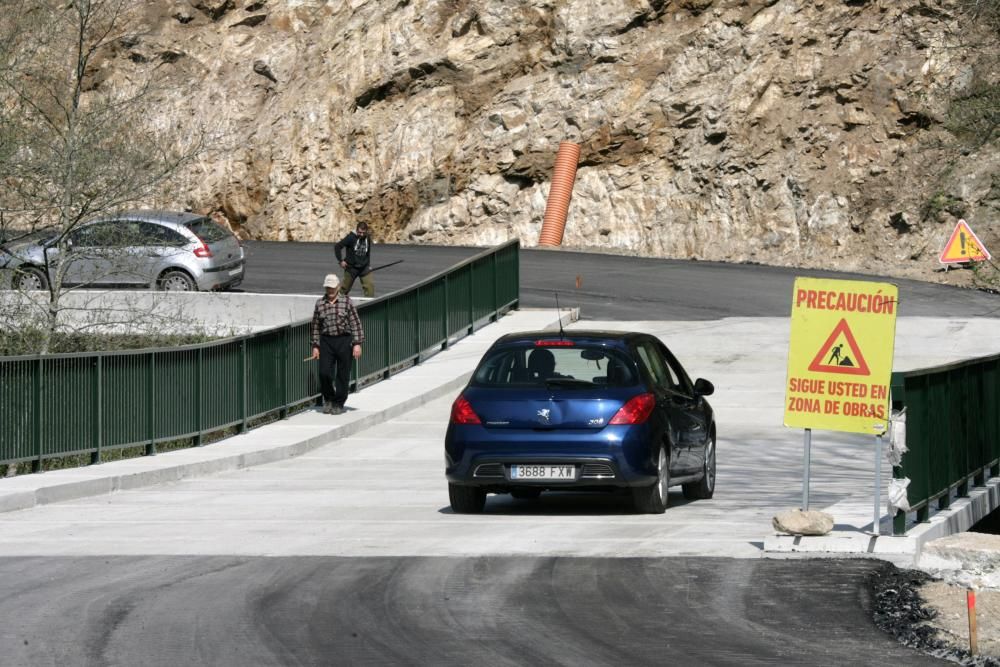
[{"left": 241, "top": 241, "right": 1000, "bottom": 321}]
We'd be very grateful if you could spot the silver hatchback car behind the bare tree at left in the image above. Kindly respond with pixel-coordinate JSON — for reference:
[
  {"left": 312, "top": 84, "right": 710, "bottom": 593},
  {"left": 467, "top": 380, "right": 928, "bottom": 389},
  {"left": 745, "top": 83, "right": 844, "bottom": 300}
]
[{"left": 0, "top": 210, "right": 245, "bottom": 291}]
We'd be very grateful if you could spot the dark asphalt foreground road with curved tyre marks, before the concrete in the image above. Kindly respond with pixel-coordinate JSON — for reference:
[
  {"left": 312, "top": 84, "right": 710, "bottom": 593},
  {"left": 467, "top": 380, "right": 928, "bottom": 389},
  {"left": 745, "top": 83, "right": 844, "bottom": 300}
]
[{"left": 0, "top": 556, "right": 939, "bottom": 667}]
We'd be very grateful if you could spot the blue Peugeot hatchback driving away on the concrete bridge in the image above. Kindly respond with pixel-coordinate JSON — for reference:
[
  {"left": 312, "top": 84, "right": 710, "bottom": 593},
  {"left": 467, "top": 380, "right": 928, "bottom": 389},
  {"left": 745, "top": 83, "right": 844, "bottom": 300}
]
[{"left": 445, "top": 330, "right": 716, "bottom": 514}]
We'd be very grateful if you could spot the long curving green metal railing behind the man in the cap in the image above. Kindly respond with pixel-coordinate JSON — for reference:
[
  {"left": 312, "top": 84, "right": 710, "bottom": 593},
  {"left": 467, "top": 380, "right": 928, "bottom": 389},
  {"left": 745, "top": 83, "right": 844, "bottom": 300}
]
[{"left": 0, "top": 241, "right": 520, "bottom": 471}]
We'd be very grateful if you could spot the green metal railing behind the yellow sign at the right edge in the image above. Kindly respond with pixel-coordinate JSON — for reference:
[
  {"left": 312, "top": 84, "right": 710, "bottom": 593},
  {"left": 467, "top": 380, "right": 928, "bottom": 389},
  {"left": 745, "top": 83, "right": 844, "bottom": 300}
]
[{"left": 892, "top": 355, "right": 1000, "bottom": 535}]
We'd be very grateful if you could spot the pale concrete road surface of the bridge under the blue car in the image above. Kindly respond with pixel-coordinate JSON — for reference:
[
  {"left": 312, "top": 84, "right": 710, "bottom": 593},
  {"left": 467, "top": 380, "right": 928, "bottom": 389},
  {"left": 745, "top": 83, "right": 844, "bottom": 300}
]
[{"left": 0, "top": 313, "right": 998, "bottom": 558}]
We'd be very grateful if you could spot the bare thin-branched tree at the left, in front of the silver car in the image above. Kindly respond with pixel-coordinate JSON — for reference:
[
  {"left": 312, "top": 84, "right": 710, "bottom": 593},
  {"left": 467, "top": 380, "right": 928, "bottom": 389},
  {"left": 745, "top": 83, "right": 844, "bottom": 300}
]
[{"left": 0, "top": 0, "right": 208, "bottom": 354}]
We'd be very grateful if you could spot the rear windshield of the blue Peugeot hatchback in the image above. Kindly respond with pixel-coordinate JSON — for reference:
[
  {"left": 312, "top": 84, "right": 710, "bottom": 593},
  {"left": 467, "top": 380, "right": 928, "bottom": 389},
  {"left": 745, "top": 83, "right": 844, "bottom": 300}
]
[{"left": 472, "top": 345, "right": 637, "bottom": 389}]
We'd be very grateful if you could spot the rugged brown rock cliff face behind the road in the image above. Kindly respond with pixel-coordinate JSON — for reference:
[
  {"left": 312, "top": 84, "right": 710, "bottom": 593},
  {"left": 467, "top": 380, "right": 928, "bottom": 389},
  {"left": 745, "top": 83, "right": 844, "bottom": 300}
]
[{"left": 101, "top": 0, "right": 1000, "bottom": 280}]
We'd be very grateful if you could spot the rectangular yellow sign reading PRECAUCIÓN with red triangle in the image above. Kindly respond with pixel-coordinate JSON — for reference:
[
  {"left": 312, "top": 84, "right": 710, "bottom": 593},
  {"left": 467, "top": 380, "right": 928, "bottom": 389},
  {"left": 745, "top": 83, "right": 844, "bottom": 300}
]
[{"left": 785, "top": 278, "right": 899, "bottom": 435}]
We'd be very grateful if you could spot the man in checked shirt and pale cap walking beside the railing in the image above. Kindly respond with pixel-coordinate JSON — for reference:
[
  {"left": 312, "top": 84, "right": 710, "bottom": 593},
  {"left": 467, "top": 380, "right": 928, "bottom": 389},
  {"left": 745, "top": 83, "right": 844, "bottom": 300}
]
[{"left": 310, "top": 273, "right": 365, "bottom": 415}]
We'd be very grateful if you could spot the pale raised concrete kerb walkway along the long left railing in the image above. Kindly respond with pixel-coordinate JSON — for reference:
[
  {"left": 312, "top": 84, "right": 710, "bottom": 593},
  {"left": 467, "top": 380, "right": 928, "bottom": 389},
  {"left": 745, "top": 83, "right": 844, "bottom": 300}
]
[{"left": 0, "top": 309, "right": 579, "bottom": 512}]
